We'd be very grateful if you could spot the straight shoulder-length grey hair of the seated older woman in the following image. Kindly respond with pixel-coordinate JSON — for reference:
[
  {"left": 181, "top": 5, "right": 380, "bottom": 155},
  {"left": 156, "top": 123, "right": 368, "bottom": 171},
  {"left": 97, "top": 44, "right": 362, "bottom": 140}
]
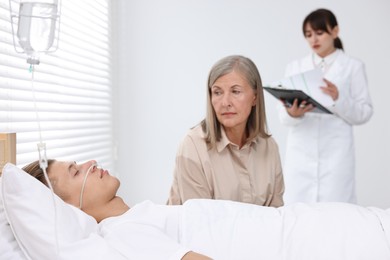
[{"left": 201, "top": 55, "right": 271, "bottom": 148}]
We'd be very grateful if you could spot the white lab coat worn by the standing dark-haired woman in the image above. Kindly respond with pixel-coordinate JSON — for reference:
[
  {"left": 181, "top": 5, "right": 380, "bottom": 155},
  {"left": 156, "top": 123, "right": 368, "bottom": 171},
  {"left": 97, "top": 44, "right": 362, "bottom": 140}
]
[{"left": 279, "top": 50, "right": 373, "bottom": 204}]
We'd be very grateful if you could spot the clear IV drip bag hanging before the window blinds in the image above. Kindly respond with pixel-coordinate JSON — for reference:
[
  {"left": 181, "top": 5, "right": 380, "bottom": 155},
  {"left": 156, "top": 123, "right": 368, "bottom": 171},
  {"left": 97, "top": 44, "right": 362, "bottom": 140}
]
[{"left": 9, "top": 0, "right": 60, "bottom": 64}]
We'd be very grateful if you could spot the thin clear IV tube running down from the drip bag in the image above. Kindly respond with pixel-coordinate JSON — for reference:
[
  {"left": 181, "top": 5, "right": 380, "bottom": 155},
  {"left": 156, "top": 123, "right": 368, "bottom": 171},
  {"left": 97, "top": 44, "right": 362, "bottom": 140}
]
[{"left": 29, "top": 64, "right": 60, "bottom": 255}]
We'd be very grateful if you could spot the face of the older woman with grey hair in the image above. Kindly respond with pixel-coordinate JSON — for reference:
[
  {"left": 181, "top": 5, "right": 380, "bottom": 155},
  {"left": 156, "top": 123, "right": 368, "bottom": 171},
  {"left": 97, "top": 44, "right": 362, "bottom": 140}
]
[{"left": 211, "top": 71, "right": 256, "bottom": 134}]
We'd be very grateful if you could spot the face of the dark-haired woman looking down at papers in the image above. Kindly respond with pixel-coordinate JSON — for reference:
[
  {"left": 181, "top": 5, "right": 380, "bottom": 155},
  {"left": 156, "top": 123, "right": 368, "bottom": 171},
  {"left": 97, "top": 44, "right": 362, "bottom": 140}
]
[{"left": 305, "top": 23, "right": 338, "bottom": 57}]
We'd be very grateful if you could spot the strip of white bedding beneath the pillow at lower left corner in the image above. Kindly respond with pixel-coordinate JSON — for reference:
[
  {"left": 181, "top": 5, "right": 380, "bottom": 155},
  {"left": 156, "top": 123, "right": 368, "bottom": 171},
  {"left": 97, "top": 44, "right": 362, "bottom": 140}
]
[{"left": 0, "top": 177, "right": 27, "bottom": 260}]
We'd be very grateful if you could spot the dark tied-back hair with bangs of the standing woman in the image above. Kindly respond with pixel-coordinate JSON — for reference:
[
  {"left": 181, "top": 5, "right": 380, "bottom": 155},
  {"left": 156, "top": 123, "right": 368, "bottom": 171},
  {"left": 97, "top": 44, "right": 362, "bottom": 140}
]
[{"left": 302, "top": 9, "right": 344, "bottom": 50}]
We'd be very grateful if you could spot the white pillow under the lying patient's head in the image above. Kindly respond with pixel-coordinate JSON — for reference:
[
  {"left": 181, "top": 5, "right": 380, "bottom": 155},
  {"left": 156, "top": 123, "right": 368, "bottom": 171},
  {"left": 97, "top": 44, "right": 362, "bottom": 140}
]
[{"left": 2, "top": 163, "right": 123, "bottom": 260}]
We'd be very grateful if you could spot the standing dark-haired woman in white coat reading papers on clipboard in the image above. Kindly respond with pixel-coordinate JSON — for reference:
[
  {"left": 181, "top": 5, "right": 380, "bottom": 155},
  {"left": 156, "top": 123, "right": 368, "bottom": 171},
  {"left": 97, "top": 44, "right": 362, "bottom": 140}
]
[{"left": 279, "top": 9, "right": 373, "bottom": 204}]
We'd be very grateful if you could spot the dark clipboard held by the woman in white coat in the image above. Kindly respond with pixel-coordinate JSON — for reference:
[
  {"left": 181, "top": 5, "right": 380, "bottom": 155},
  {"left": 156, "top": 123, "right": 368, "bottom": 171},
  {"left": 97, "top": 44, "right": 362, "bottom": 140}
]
[{"left": 263, "top": 87, "right": 333, "bottom": 114}]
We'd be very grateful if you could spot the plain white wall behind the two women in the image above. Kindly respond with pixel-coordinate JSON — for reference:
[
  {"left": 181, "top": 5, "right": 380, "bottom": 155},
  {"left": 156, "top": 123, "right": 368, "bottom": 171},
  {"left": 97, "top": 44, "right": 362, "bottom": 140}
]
[{"left": 113, "top": 0, "right": 390, "bottom": 208}]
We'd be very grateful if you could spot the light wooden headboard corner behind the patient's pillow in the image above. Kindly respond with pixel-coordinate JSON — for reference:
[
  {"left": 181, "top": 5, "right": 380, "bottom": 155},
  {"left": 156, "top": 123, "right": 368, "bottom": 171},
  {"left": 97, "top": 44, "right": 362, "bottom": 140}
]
[{"left": 0, "top": 133, "right": 16, "bottom": 175}]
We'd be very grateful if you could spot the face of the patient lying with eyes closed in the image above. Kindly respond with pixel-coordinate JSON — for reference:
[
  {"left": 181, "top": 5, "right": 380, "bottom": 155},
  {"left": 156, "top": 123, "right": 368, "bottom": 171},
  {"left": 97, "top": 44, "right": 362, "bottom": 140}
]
[{"left": 48, "top": 161, "right": 119, "bottom": 209}]
